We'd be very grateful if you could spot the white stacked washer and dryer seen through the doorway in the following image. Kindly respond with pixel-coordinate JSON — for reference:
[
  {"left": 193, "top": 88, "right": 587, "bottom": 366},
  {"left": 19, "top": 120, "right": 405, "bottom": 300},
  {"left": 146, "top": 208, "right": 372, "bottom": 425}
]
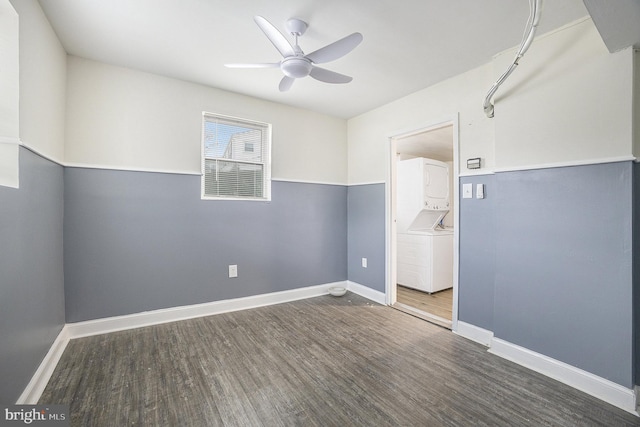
[{"left": 396, "top": 157, "right": 453, "bottom": 293}]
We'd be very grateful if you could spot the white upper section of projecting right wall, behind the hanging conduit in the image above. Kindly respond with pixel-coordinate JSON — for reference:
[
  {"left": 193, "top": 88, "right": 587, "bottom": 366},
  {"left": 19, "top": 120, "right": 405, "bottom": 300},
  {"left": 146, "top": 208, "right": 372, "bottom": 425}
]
[{"left": 493, "top": 19, "right": 633, "bottom": 169}]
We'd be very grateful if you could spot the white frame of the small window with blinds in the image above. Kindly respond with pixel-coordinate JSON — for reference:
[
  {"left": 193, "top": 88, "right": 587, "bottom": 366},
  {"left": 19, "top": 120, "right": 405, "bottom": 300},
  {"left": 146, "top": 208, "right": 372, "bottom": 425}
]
[{"left": 200, "top": 111, "right": 271, "bottom": 202}]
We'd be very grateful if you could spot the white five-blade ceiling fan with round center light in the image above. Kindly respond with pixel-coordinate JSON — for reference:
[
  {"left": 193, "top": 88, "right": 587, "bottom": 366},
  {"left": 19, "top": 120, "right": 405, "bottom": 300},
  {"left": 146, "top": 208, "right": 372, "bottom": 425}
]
[{"left": 225, "top": 16, "right": 362, "bottom": 92}]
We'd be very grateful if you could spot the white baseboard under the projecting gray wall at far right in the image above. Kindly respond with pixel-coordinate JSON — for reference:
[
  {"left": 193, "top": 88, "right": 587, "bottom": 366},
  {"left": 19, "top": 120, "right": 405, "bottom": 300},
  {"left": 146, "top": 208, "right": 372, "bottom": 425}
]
[{"left": 489, "top": 338, "right": 638, "bottom": 415}]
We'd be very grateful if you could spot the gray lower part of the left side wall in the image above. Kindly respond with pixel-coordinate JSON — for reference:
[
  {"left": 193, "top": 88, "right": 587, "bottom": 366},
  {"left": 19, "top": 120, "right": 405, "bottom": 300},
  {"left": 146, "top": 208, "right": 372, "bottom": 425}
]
[{"left": 0, "top": 148, "right": 65, "bottom": 404}]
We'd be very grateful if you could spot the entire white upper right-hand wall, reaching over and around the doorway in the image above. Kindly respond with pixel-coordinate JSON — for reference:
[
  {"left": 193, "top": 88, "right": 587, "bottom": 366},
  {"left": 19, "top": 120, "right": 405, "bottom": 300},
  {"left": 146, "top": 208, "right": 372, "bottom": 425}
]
[{"left": 348, "top": 19, "right": 640, "bottom": 184}]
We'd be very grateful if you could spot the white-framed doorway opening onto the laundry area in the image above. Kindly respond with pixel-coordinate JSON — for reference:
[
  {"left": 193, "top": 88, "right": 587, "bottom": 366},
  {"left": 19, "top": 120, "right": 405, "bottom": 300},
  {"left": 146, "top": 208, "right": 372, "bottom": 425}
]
[{"left": 387, "top": 118, "right": 458, "bottom": 330}]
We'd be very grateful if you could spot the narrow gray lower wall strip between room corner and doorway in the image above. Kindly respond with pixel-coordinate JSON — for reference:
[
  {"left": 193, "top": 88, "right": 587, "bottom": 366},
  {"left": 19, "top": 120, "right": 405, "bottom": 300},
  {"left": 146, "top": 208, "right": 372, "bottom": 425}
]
[{"left": 347, "top": 184, "right": 385, "bottom": 292}]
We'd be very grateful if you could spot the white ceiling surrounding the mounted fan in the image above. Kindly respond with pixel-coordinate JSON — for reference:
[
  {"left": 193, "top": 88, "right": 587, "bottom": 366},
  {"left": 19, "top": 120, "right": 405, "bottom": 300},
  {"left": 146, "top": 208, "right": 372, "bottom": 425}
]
[{"left": 39, "top": 0, "right": 588, "bottom": 118}]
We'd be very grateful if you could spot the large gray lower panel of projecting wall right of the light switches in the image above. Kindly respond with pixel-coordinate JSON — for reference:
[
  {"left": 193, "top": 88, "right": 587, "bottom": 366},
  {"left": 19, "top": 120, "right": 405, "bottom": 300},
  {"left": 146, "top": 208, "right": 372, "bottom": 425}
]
[{"left": 493, "top": 162, "right": 633, "bottom": 387}]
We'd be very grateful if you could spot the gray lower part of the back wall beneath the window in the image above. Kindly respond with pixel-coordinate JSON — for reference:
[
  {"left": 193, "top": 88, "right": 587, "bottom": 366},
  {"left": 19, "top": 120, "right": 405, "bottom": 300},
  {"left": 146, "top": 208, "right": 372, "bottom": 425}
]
[{"left": 64, "top": 168, "right": 347, "bottom": 322}]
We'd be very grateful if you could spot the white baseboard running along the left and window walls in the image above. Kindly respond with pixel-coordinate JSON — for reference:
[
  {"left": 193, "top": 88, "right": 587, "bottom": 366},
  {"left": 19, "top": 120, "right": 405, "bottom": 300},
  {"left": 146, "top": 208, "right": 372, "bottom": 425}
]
[{"left": 16, "top": 281, "right": 347, "bottom": 404}]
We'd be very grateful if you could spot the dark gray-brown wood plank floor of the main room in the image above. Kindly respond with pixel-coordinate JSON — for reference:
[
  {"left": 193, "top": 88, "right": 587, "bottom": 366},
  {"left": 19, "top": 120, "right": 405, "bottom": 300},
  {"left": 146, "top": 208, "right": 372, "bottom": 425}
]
[{"left": 40, "top": 293, "right": 640, "bottom": 426}]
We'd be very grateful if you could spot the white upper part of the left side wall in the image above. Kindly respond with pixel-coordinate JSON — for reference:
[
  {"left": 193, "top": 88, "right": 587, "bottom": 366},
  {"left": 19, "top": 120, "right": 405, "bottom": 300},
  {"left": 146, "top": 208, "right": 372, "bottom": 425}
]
[{"left": 11, "top": 0, "right": 67, "bottom": 163}]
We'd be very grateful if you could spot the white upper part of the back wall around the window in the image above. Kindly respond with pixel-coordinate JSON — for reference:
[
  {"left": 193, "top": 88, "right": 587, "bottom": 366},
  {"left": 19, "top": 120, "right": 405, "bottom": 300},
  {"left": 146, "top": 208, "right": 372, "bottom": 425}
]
[{"left": 65, "top": 56, "right": 347, "bottom": 184}]
